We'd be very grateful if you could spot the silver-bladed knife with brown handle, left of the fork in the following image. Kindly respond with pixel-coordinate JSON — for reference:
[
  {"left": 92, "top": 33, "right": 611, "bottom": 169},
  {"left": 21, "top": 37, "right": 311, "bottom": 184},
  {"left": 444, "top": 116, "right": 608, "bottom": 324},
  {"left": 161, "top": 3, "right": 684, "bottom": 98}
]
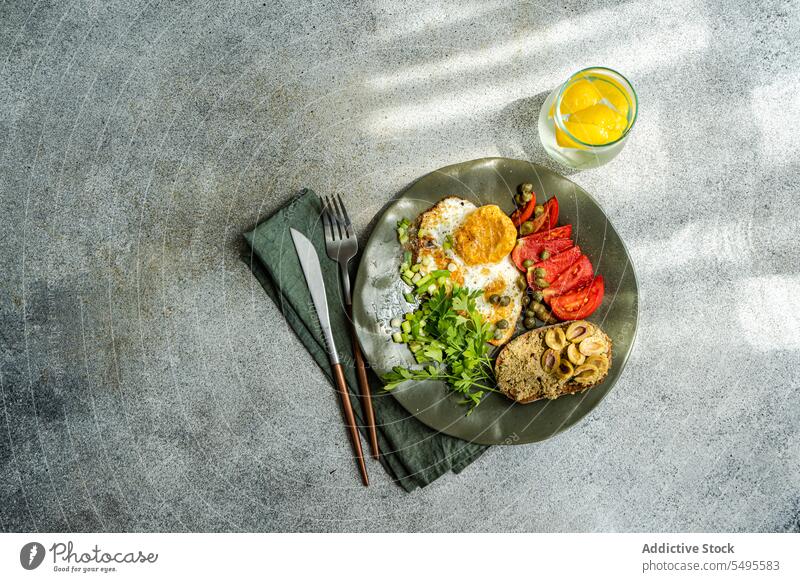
[{"left": 289, "top": 228, "right": 369, "bottom": 486}]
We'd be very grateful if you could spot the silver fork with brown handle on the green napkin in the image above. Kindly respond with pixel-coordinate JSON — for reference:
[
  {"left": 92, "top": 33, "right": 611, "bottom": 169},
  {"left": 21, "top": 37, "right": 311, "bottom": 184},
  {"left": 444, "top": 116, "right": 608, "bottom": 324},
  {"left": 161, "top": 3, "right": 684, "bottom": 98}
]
[{"left": 322, "top": 194, "right": 380, "bottom": 459}]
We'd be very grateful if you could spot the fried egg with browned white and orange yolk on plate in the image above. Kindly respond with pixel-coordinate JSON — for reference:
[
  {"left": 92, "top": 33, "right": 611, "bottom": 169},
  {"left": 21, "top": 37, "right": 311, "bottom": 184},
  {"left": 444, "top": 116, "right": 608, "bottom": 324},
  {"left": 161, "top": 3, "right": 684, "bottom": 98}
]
[{"left": 411, "top": 196, "right": 526, "bottom": 345}]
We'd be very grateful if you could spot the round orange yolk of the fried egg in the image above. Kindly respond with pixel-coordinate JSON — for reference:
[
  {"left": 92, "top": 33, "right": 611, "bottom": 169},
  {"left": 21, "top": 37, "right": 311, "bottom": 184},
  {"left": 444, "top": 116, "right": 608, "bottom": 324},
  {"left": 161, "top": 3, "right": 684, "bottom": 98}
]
[{"left": 453, "top": 204, "right": 517, "bottom": 265}]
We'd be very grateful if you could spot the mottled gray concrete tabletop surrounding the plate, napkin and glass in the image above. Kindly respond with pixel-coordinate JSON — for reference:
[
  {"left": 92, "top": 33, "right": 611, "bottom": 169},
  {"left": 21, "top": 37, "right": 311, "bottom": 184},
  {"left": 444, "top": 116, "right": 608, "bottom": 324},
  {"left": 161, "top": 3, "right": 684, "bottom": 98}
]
[{"left": 0, "top": 0, "right": 800, "bottom": 531}]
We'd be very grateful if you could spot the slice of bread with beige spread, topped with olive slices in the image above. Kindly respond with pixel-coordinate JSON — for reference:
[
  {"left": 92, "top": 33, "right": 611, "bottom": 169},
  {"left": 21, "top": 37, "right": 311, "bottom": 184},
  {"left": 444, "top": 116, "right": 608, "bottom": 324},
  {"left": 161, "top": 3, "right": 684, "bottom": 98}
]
[{"left": 495, "top": 321, "right": 612, "bottom": 404}]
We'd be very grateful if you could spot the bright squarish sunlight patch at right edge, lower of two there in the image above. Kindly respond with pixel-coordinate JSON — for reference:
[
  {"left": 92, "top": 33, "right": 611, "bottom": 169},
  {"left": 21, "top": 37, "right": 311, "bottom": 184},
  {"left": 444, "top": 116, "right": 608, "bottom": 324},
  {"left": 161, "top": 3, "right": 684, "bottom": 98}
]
[{"left": 738, "top": 275, "right": 800, "bottom": 352}]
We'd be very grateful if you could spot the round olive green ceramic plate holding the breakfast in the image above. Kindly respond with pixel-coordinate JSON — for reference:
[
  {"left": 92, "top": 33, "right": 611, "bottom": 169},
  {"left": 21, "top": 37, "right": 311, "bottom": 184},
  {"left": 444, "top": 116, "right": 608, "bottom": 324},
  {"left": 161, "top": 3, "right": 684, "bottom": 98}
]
[{"left": 353, "top": 158, "right": 638, "bottom": 444}]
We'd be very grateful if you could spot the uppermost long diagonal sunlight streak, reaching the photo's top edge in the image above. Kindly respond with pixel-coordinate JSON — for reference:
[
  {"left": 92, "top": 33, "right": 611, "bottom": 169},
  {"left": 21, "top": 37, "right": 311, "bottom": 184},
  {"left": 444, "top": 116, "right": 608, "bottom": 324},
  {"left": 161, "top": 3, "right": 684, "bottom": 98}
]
[{"left": 368, "top": 0, "right": 695, "bottom": 90}]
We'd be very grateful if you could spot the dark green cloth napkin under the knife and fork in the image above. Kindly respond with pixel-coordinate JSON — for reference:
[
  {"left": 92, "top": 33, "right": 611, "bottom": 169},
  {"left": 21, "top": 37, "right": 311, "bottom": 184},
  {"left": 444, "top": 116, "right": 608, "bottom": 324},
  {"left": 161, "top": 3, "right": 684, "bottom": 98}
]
[{"left": 243, "top": 189, "right": 487, "bottom": 491}]
